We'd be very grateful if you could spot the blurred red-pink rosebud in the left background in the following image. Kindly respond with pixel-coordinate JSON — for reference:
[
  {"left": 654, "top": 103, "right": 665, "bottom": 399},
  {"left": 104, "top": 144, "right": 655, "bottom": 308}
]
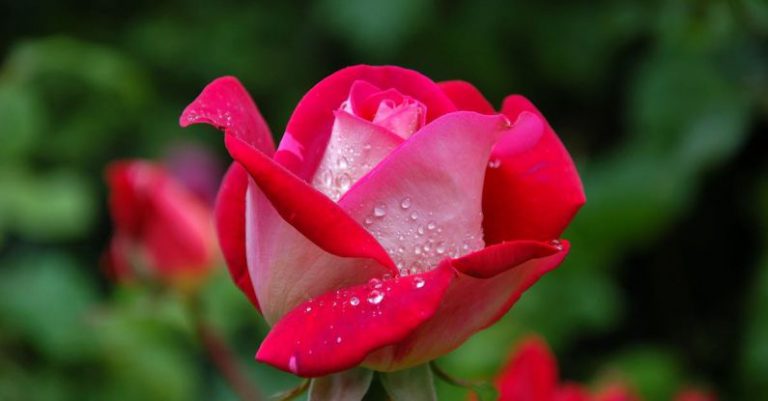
[{"left": 106, "top": 160, "right": 217, "bottom": 285}]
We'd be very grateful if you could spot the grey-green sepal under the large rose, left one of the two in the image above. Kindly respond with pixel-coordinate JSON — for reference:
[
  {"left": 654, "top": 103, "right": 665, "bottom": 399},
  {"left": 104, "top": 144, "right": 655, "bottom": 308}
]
[{"left": 308, "top": 368, "right": 373, "bottom": 401}]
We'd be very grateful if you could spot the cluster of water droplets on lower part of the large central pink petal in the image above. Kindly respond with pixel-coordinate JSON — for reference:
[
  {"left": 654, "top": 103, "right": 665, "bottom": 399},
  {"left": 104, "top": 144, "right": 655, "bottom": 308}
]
[{"left": 363, "top": 197, "right": 484, "bottom": 276}]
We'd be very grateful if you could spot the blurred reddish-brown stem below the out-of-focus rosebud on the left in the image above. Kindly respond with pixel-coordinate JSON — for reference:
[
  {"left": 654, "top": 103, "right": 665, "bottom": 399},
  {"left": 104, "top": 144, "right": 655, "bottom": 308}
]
[{"left": 188, "top": 294, "right": 264, "bottom": 401}]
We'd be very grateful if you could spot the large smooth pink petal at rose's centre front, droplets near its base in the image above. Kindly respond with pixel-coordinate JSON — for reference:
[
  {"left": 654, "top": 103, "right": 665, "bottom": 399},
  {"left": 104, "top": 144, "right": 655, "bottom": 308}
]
[{"left": 339, "top": 112, "right": 536, "bottom": 274}]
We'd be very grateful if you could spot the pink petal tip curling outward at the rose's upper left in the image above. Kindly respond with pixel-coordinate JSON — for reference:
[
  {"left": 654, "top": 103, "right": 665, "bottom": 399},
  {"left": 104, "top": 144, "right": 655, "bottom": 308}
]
[{"left": 179, "top": 77, "right": 275, "bottom": 156}]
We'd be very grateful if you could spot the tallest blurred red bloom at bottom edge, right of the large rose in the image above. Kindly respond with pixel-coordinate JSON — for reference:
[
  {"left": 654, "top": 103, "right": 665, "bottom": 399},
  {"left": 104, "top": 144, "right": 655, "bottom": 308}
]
[{"left": 497, "top": 337, "right": 557, "bottom": 401}]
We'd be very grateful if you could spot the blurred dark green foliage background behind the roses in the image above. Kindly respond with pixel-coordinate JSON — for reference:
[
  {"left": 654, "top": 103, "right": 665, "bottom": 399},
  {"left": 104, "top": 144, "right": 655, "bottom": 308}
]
[{"left": 0, "top": 0, "right": 768, "bottom": 401}]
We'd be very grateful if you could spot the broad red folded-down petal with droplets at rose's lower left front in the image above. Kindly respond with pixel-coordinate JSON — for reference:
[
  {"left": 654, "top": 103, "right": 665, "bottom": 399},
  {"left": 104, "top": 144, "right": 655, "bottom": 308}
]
[{"left": 256, "top": 262, "right": 455, "bottom": 376}]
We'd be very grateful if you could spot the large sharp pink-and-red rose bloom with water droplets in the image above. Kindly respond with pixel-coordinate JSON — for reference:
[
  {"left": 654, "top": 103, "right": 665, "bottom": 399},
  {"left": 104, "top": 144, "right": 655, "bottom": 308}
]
[{"left": 180, "top": 66, "right": 585, "bottom": 377}]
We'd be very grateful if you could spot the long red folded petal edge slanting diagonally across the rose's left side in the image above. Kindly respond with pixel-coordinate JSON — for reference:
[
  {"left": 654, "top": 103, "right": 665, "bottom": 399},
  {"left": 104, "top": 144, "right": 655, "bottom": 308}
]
[{"left": 224, "top": 135, "right": 396, "bottom": 272}]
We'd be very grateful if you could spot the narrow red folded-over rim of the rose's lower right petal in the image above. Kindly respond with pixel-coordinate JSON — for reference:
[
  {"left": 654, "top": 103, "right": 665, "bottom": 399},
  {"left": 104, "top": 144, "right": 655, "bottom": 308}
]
[{"left": 453, "top": 240, "right": 563, "bottom": 278}]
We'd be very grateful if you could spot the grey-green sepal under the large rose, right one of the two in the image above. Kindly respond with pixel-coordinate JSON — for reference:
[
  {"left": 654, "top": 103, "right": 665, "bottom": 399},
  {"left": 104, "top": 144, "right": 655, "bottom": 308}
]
[{"left": 379, "top": 363, "right": 437, "bottom": 401}]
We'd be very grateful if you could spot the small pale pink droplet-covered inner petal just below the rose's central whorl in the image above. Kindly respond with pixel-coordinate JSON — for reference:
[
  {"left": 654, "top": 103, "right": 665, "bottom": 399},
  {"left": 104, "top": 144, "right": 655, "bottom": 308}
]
[{"left": 312, "top": 111, "right": 403, "bottom": 201}]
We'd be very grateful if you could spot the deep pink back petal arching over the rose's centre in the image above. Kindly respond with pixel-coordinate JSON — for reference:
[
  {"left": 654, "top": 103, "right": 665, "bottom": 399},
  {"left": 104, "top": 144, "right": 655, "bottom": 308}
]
[{"left": 275, "top": 65, "right": 456, "bottom": 181}]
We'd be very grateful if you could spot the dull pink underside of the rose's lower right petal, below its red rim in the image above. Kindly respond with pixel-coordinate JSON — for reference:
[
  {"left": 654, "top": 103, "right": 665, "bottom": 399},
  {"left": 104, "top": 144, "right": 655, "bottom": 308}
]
[{"left": 364, "top": 239, "right": 569, "bottom": 371}]
